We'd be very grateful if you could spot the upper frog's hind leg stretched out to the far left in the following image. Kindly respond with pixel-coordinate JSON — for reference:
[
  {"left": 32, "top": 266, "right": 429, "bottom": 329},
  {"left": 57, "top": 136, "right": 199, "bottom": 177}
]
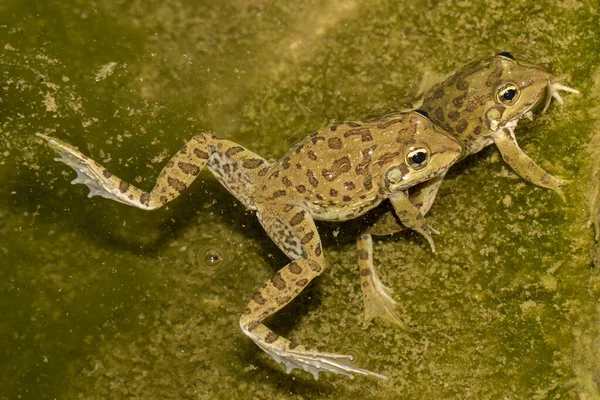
[{"left": 36, "top": 133, "right": 268, "bottom": 210}]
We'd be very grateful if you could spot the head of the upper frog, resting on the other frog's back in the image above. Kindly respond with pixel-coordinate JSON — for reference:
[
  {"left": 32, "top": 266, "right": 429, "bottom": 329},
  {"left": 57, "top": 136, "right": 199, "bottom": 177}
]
[{"left": 385, "top": 110, "right": 463, "bottom": 193}]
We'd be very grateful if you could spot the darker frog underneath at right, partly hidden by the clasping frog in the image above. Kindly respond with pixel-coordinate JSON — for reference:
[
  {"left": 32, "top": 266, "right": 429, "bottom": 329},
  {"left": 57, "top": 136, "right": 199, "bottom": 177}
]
[{"left": 356, "top": 52, "right": 580, "bottom": 327}]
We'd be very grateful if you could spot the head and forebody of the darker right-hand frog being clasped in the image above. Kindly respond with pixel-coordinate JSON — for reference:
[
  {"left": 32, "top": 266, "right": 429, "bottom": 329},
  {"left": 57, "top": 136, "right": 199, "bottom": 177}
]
[{"left": 422, "top": 52, "right": 577, "bottom": 154}]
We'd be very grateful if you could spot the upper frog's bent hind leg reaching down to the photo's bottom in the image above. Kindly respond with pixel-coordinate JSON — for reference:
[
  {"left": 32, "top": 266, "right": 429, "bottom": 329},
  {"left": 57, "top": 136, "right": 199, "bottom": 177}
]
[{"left": 240, "top": 204, "right": 386, "bottom": 379}]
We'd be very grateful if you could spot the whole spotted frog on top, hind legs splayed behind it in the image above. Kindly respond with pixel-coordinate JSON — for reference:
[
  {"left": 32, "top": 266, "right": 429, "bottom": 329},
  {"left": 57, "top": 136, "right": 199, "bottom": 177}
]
[{"left": 37, "top": 110, "right": 463, "bottom": 379}]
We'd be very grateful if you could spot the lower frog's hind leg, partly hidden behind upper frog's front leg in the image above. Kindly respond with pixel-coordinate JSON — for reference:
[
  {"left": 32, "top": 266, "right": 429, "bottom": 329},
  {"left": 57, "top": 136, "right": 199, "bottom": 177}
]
[{"left": 356, "top": 174, "right": 445, "bottom": 328}]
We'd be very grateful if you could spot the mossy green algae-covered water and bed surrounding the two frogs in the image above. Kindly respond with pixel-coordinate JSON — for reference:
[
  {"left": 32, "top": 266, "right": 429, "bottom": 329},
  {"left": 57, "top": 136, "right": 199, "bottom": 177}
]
[{"left": 0, "top": 0, "right": 600, "bottom": 399}]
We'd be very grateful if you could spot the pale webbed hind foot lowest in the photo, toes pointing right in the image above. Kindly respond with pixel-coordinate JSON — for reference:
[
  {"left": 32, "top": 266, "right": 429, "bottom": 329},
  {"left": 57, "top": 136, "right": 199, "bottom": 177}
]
[{"left": 255, "top": 342, "right": 387, "bottom": 380}]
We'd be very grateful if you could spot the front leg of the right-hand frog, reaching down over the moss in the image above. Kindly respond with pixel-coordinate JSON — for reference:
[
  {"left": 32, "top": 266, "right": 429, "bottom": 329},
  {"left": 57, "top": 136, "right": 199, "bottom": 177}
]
[{"left": 492, "top": 126, "right": 565, "bottom": 201}]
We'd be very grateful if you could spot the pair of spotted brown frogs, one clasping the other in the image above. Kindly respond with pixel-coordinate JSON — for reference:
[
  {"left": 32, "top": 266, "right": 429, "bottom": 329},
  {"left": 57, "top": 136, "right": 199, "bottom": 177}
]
[{"left": 38, "top": 53, "right": 578, "bottom": 379}]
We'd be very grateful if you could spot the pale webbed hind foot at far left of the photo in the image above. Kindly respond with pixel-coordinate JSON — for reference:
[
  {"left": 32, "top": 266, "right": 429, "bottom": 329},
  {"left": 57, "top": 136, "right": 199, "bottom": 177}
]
[{"left": 35, "top": 133, "right": 134, "bottom": 204}]
